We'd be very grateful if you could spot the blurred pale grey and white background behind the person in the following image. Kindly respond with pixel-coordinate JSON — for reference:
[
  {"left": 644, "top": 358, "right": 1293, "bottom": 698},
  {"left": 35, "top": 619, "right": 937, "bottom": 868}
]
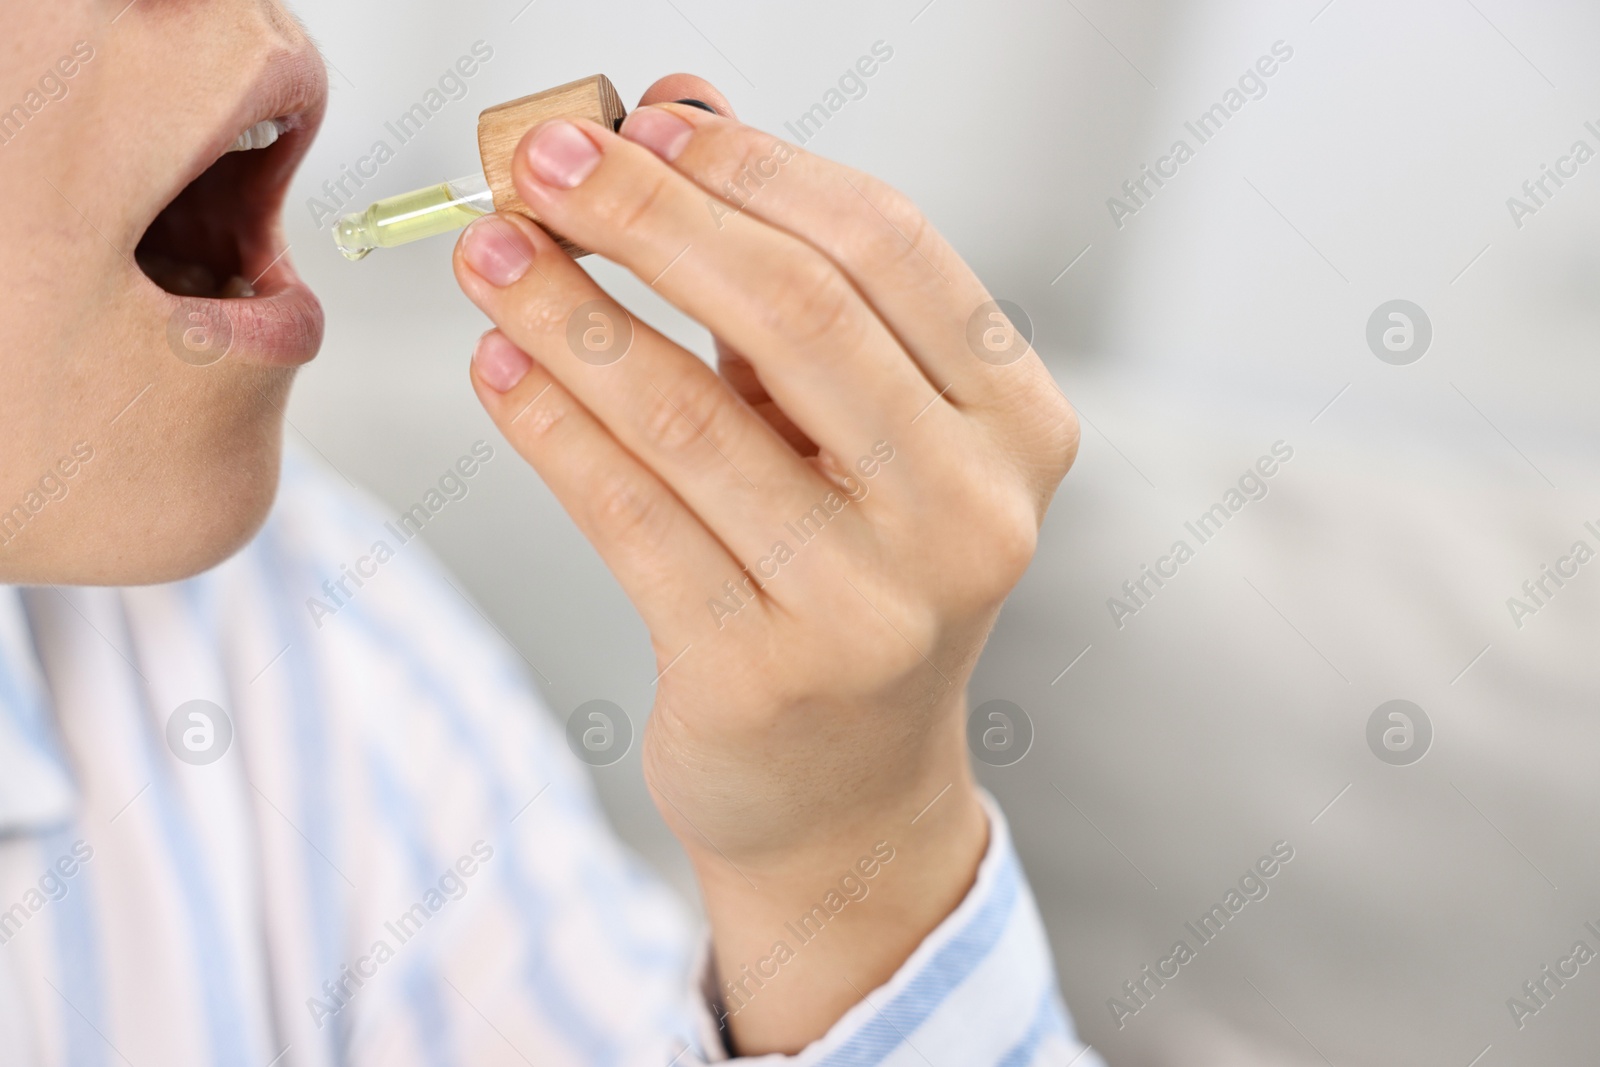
[{"left": 288, "top": 0, "right": 1600, "bottom": 1067}]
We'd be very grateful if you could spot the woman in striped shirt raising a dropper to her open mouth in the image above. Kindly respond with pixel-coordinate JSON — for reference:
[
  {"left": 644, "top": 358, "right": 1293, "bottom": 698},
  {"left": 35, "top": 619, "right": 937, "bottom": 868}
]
[{"left": 0, "top": 0, "right": 1093, "bottom": 1067}]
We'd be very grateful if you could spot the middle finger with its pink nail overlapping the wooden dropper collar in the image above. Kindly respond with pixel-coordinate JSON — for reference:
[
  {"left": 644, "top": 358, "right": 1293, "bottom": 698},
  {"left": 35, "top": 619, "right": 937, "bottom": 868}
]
[{"left": 499, "top": 122, "right": 963, "bottom": 461}]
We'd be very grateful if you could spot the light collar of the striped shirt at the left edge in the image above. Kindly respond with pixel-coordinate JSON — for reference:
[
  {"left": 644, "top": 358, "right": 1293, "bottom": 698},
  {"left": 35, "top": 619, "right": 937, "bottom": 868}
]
[{"left": 0, "top": 585, "right": 77, "bottom": 837}]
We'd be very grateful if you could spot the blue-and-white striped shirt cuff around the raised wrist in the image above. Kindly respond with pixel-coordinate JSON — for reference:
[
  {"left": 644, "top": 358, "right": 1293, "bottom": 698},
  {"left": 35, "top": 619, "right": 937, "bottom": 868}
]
[{"left": 681, "top": 793, "right": 1101, "bottom": 1067}]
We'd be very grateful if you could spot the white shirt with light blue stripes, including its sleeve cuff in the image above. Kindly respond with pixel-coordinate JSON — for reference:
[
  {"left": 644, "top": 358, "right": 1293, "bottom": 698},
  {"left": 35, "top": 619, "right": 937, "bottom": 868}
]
[{"left": 0, "top": 445, "right": 1099, "bottom": 1067}]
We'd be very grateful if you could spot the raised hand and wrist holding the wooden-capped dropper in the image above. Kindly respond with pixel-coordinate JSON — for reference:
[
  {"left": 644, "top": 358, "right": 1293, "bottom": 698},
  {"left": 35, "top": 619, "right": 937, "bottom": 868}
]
[{"left": 456, "top": 75, "right": 1078, "bottom": 1054}]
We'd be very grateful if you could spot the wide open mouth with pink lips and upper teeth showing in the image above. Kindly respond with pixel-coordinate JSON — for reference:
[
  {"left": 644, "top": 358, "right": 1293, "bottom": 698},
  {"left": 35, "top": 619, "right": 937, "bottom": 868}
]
[{"left": 134, "top": 50, "right": 326, "bottom": 365}]
